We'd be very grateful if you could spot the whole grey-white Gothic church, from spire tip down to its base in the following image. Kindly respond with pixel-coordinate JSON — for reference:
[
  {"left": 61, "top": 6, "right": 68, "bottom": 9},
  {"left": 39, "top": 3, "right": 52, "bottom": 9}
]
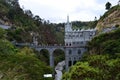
[{"left": 64, "top": 16, "right": 96, "bottom": 69}]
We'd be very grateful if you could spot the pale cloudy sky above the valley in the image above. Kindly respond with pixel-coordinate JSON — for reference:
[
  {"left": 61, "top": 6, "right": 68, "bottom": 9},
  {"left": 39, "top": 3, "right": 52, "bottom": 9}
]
[{"left": 19, "top": 0, "right": 118, "bottom": 23}]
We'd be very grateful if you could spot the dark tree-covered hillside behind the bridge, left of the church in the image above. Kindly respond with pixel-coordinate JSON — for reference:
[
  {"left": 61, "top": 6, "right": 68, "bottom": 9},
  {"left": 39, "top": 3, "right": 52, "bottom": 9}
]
[{"left": 0, "top": 0, "right": 64, "bottom": 44}]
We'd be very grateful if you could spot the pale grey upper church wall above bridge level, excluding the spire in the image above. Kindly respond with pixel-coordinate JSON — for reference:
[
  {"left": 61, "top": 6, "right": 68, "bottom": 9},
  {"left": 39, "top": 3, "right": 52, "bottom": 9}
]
[{"left": 65, "top": 30, "right": 96, "bottom": 46}]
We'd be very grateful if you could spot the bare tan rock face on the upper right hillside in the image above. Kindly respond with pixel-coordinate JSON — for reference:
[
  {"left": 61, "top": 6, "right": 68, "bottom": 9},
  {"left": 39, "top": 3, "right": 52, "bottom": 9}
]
[{"left": 96, "top": 5, "right": 120, "bottom": 32}]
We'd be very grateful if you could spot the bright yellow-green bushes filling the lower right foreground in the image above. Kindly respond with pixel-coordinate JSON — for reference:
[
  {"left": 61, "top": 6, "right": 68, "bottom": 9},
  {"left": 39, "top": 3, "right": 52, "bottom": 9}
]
[{"left": 62, "top": 55, "right": 120, "bottom": 80}]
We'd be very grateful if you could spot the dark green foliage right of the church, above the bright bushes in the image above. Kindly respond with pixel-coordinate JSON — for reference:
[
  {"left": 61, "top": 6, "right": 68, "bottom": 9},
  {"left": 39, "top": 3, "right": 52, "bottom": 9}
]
[{"left": 88, "top": 28, "right": 120, "bottom": 54}]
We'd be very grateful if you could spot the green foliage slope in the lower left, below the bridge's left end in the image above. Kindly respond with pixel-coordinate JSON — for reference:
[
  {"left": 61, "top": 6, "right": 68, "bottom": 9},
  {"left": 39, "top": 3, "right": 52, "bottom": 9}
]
[{"left": 0, "top": 28, "right": 53, "bottom": 80}]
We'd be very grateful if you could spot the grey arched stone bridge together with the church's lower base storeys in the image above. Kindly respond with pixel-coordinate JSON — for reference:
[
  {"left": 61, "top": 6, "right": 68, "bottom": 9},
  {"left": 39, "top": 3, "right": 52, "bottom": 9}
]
[{"left": 15, "top": 43, "right": 87, "bottom": 70}]
